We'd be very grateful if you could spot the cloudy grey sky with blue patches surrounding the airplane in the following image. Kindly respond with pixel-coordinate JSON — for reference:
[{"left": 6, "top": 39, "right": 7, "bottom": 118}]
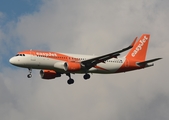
[{"left": 0, "top": 0, "right": 169, "bottom": 120}]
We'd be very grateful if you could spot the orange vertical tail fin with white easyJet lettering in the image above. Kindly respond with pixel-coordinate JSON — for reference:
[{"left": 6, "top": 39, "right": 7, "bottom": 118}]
[{"left": 126, "top": 34, "right": 150, "bottom": 62}]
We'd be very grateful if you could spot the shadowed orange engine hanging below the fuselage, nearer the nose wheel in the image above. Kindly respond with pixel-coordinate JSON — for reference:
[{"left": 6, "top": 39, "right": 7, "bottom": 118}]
[{"left": 40, "top": 70, "right": 61, "bottom": 79}]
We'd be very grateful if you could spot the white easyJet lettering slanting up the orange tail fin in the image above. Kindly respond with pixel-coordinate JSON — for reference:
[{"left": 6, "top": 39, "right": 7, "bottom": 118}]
[{"left": 131, "top": 36, "right": 148, "bottom": 57}]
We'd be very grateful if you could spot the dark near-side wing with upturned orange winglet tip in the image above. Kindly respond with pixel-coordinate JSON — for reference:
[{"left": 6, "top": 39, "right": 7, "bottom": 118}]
[{"left": 81, "top": 37, "right": 137, "bottom": 69}]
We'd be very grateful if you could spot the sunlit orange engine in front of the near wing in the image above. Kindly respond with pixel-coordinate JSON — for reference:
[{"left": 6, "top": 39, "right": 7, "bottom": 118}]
[{"left": 64, "top": 62, "right": 82, "bottom": 71}]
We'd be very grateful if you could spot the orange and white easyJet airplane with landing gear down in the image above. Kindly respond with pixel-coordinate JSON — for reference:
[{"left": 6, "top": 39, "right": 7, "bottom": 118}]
[{"left": 9, "top": 34, "right": 162, "bottom": 84}]
